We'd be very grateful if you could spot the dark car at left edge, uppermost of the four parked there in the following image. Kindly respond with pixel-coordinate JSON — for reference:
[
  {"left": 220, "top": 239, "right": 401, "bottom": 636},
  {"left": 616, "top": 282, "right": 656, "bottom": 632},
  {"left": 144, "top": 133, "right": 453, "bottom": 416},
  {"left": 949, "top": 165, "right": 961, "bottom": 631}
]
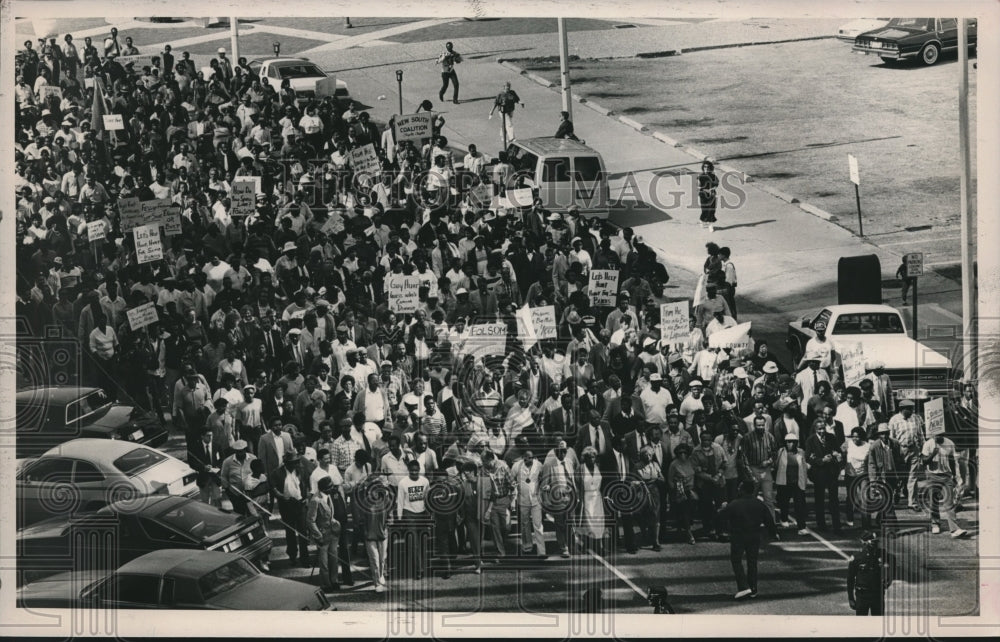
[{"left": 16, "top": 386, "right": 169, "bottom": 458}]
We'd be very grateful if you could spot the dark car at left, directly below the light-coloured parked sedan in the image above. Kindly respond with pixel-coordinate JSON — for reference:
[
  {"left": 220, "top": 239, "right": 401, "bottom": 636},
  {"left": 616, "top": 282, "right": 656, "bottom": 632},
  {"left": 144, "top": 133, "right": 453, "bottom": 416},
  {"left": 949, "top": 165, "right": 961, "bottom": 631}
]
[{"left": 17, "top": 495, "right": 272, "bottom": 581}]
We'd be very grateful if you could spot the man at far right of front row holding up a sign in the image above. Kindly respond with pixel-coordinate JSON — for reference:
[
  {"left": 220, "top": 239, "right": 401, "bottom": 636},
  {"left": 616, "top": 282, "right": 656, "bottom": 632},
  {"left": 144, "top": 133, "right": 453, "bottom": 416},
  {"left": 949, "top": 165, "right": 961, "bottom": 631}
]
[{"left": 910, "top": 398, "right": 969, "bottom": 539}]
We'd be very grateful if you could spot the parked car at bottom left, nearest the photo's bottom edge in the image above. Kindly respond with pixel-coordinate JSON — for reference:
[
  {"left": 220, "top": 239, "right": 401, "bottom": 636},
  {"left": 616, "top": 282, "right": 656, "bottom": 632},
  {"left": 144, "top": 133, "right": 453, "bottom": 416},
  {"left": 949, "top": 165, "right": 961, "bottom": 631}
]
[{"left": 16, "top": 549, "right": 337, "bottom": 611}]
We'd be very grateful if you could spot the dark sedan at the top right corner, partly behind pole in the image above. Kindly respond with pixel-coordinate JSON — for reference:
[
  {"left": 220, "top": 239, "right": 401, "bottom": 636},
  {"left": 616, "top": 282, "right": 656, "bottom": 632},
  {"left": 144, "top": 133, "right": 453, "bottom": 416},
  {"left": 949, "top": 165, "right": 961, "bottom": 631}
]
[{"left": 853, "top": 18, "right": 976, "bottom": 65}]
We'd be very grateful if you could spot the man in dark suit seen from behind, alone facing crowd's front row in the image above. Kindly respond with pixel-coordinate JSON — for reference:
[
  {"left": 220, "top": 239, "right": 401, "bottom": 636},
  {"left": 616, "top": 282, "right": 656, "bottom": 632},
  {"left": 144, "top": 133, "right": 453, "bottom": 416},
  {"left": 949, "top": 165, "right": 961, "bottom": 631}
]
[{"left": 719, "top": 482, "right": 780, "bottom": 600}]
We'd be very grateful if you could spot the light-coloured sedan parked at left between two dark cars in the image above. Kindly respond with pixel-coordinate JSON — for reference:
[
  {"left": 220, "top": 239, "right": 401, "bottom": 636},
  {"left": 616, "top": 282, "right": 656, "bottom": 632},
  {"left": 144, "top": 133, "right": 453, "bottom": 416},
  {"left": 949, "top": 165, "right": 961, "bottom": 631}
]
[{"left": 15, "top": 439, "right": 198, "bottom": 527}]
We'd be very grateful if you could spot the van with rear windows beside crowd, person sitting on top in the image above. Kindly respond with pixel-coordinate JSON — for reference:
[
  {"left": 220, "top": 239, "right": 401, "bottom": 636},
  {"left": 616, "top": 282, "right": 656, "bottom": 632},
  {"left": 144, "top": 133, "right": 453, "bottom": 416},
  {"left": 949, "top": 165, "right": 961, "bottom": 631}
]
[{"left": 507, "top": 137, "right": 610, "bottom": 218}]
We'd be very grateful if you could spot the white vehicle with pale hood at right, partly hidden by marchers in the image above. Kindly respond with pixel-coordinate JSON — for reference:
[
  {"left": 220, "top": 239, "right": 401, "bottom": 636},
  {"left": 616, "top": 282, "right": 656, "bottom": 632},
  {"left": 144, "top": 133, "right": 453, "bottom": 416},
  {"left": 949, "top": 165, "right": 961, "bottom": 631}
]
[{"left": 786, "top": 304, "right": 951, "bottom": 396}]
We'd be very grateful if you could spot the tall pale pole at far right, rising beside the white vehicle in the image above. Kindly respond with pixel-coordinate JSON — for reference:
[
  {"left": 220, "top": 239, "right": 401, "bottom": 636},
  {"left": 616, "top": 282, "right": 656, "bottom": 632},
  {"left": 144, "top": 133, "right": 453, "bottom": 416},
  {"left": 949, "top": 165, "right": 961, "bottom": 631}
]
[{"left": 958, "top": 18, "right": 977, "bottom": 380}]
